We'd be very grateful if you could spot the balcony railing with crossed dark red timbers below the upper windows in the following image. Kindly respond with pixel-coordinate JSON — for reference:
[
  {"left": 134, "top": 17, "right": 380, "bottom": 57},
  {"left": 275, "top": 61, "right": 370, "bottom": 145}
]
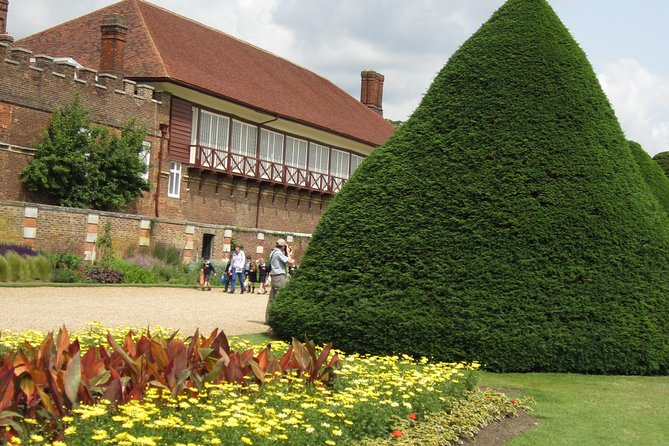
[{"left": 190, "top": 146, "right": 346, "bottom": 194}]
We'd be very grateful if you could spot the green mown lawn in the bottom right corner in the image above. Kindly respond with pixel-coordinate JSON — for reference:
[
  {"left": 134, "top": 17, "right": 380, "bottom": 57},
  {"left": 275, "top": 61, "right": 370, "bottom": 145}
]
[{"left": 480, "top": 373, "right": 669, "bottom": 446}]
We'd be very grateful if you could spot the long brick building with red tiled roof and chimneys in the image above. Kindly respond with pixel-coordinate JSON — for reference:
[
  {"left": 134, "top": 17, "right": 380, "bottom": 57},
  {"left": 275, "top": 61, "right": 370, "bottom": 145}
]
[{"left": 0, "top": 0, "right": 393, "bottom": 264}]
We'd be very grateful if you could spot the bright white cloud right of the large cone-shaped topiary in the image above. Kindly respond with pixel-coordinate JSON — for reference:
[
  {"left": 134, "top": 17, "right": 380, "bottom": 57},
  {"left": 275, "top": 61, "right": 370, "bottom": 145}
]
[{"left": 598, "top": 59, "right": 669, "bottom": 155}]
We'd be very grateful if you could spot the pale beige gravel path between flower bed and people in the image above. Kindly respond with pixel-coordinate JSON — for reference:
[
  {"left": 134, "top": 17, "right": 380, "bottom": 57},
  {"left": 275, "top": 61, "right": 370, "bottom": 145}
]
[{"left": 0, "top": 287, "right": 269, "bottom": 335}]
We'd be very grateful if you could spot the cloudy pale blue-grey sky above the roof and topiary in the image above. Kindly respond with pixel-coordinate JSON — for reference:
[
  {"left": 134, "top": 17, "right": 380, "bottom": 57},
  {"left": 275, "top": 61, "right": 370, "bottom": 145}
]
[{"left": 7, "top": 0, "right": 669, "bottom": 155}]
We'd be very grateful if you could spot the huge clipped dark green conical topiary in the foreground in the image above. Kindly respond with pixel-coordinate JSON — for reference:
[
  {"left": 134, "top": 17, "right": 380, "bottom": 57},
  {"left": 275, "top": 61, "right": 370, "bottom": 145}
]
[{"left": 270, "top": 0, "right": 669, "bottom": 374}]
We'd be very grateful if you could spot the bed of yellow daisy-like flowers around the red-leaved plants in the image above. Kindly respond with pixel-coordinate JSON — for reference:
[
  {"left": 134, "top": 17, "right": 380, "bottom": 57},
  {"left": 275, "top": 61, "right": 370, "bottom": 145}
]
[{"left": 0, "top": 326, "right": 524, "bottom": 445}]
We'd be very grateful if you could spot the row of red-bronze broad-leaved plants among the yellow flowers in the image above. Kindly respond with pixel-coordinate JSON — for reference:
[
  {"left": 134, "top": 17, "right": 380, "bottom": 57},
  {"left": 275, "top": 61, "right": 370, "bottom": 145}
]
[{"left": 0, "top": 327, "right": 341, "bottom": 441}]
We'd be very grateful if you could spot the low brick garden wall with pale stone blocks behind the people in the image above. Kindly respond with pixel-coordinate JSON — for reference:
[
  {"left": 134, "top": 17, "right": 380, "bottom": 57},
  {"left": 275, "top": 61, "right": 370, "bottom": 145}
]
[{"left": 0, "top": 200, "right": 310, "bottom": 260}]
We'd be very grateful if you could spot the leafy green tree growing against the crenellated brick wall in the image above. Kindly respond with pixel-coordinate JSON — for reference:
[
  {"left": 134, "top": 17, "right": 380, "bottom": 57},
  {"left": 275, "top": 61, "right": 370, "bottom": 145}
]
[{"left": 21, "top": 98, "right": 149, "bottom": 210}]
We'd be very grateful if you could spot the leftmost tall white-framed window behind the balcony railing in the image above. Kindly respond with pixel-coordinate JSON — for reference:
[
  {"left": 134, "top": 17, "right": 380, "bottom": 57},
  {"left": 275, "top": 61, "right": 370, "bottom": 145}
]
[{"left": 199, "top": 110, "right": 230, "bottom": 170}]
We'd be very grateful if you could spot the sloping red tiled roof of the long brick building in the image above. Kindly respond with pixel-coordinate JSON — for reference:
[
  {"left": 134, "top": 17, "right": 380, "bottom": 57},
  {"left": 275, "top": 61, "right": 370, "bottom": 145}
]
[{"left": 15, "top": 0, "right": 393, "bottom": 145}]
